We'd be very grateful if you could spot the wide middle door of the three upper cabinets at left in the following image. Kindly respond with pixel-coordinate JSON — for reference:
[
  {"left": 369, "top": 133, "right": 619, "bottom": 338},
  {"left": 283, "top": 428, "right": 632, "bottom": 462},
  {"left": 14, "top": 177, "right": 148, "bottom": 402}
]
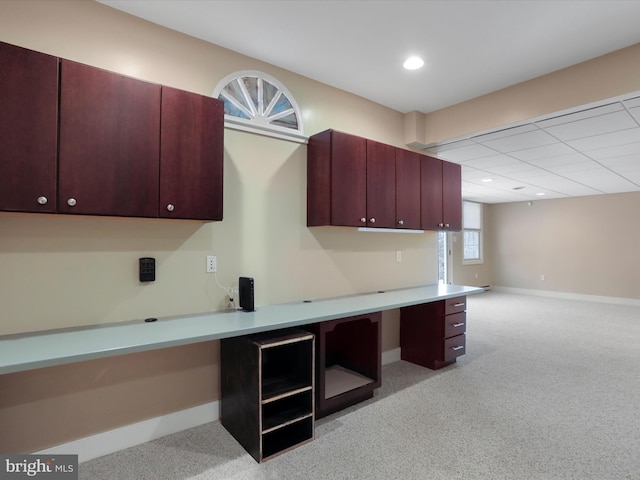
[{"left": 58, "top": 60, "right": 160, "bottom": 217}]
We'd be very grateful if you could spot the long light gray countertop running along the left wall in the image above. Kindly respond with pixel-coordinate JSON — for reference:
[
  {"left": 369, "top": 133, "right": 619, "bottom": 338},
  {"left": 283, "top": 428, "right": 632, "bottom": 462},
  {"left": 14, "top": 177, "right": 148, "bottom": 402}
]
[{"left": 0, "top": 285, "right": 484, "bottom": 374}]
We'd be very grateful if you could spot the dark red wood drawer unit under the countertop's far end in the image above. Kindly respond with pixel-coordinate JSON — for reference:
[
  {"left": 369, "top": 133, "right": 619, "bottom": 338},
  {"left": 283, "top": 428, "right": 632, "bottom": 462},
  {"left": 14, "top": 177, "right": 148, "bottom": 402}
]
[{"left": 400, "top": 296, "right": 467, "bottom": 370}]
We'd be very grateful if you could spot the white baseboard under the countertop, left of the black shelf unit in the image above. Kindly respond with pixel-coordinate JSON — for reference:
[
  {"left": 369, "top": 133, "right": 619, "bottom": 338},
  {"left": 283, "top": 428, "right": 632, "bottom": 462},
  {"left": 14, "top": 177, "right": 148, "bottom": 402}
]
[{"left": 35, "top": 401, "right": 220, "bottom": 463}]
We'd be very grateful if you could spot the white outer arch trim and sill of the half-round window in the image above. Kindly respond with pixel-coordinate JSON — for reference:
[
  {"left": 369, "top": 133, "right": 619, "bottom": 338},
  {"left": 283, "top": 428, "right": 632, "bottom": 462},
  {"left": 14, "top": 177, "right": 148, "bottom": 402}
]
[{"left": 213, "top": 70, "right": 309, "bottom": 143}]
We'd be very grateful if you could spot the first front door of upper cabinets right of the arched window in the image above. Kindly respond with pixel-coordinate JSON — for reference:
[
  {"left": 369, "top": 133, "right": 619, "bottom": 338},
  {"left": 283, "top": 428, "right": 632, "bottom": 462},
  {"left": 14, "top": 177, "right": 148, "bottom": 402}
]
[{"left": 331, "top": 131, "right": 367, "bottom": 227}]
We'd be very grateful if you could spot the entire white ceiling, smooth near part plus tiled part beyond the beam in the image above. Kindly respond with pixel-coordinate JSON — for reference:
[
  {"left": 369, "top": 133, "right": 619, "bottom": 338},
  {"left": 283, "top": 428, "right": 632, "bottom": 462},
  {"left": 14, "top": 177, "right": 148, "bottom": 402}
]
[{"left": 99, "top": 0, "right": 640, "bottom": 203}]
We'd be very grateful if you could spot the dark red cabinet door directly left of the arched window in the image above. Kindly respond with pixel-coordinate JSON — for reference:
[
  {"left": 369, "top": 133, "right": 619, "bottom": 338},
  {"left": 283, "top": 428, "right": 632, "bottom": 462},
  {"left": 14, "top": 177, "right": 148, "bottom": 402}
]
[{"left": 159, "top": 87, "right": 224, "bottom": 220}]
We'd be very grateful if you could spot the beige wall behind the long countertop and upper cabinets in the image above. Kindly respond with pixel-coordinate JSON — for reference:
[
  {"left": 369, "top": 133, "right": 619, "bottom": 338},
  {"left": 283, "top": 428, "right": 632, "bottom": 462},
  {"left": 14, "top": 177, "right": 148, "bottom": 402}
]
[{"left": 0, "top": 0, "right": 437, "bottom": 453}]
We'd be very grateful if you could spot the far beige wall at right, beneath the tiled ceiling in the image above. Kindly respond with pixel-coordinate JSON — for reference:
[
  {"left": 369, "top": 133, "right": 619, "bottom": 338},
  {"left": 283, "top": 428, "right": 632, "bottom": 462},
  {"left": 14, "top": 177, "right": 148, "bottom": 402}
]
[{"left": 486, "top": 193, "right": 640, "bottom": 299}]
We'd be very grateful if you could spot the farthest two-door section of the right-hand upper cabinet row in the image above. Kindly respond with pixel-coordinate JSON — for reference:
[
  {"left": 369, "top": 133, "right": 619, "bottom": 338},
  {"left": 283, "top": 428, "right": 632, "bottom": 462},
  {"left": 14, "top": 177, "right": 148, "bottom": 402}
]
[{"left": 420, "top": 156, "right": 462, "bottom": 231}]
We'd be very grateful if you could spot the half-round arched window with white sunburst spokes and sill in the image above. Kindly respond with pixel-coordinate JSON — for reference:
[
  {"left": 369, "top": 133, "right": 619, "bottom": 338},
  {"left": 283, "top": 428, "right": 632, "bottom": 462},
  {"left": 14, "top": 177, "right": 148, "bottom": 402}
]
[{"left": 213, "top": 70, "right": 307, "bottom": 142}]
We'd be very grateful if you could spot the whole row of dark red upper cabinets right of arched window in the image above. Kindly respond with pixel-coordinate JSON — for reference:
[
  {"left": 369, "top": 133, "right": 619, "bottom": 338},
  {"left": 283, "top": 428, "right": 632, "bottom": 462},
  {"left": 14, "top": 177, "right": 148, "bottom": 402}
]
[{"left": 307, "top": 130, "right": 462, "bottom": 230}]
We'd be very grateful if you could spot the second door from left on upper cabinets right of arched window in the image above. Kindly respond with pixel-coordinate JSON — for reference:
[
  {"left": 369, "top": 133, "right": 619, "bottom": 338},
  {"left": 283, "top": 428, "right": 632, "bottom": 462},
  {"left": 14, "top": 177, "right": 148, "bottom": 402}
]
[{"left": 367, "top": 140, "right": 396, "bottom": 228}]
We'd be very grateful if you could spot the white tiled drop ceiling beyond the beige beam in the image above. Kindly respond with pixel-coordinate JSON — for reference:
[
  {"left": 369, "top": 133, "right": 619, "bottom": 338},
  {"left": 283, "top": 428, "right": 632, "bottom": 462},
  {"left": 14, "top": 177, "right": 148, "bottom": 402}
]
[{"left": 428, "top": 94, "right": 640, "bottom": 203}]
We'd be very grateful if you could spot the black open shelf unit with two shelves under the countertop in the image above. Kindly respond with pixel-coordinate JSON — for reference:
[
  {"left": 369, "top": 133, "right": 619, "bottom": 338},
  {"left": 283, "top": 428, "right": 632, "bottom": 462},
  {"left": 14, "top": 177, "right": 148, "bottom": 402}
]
[{"left": 220, "top": 329, "right": 315, "bottom": 462}]
